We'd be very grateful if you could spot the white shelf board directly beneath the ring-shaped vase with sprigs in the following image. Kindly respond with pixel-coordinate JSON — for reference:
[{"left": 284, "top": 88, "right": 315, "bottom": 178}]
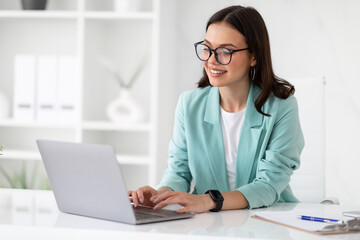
[{"left": 82, "top": 121, "right": 151, "bottom": 132}]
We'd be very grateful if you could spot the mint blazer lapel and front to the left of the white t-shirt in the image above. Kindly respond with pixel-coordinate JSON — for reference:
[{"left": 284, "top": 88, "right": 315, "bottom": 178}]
[{"left": 203, "top": 87, "right": 229, "bottom": 191}]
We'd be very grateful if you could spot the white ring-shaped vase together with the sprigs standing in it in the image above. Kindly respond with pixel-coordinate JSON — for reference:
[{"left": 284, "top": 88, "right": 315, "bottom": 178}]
[{"left": 101, "top": 55, "right": 147, "bottom": 123}]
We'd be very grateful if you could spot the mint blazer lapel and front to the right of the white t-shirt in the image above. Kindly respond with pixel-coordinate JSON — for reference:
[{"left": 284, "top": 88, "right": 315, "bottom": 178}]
[{"left": 235, "top": 84, "right": 264, "bottom": 188}]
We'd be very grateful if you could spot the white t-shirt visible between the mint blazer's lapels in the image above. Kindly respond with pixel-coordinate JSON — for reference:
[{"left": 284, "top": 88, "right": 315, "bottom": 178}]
[{"left": 220, "top": 107, "right": 246, "bottom": 191}]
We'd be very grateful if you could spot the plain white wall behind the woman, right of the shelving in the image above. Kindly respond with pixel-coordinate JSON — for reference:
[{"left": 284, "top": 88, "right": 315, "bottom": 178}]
[{"left": 159, "top": 0, "right": 360, "bottom": 204}]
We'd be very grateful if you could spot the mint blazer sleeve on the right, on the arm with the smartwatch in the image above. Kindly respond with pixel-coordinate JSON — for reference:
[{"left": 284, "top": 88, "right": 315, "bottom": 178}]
[{"left": 236, "top": 96, "right": 304, "bottom": 208}]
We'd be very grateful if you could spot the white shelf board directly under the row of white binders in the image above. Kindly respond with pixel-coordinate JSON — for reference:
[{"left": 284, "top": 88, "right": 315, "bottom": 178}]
[{"left": 0, "top": 119, "right": 76, "bottom": 129}]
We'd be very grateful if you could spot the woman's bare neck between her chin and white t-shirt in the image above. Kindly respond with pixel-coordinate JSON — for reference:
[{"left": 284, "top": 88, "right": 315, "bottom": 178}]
[{"left": 219, "top": 81, "right": 250, "bottom": 112}]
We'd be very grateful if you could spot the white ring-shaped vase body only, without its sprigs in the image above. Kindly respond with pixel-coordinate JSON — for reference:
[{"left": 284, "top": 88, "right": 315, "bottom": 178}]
[{"left": 106, "top": 88, "right": 144, "bottom": 123}]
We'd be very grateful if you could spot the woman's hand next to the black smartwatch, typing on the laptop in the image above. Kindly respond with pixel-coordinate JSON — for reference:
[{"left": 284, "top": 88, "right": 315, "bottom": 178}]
[{"left": 152, "top": 191, "right": 216, "bottom": 213}]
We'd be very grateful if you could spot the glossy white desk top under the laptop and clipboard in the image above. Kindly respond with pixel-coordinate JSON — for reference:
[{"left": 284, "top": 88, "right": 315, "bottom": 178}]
[{"left": 0, "top": 189, "right": 360, "bottom": 240}]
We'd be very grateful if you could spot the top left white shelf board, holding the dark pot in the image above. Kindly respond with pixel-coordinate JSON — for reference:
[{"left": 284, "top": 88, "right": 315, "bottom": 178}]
[{"left": 0, "top": 10, "right": 78, "bottom": 19}]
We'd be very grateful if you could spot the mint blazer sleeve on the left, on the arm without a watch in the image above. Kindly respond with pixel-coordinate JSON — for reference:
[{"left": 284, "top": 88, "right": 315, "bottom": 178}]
[{"left": 157, "top": 93, "right": 192, "bottom": 192}]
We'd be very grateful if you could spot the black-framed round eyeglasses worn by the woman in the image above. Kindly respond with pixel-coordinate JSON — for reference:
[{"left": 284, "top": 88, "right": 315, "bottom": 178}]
[{"left": 194, "top": 41, "right": 250, "bottom": 65}]
